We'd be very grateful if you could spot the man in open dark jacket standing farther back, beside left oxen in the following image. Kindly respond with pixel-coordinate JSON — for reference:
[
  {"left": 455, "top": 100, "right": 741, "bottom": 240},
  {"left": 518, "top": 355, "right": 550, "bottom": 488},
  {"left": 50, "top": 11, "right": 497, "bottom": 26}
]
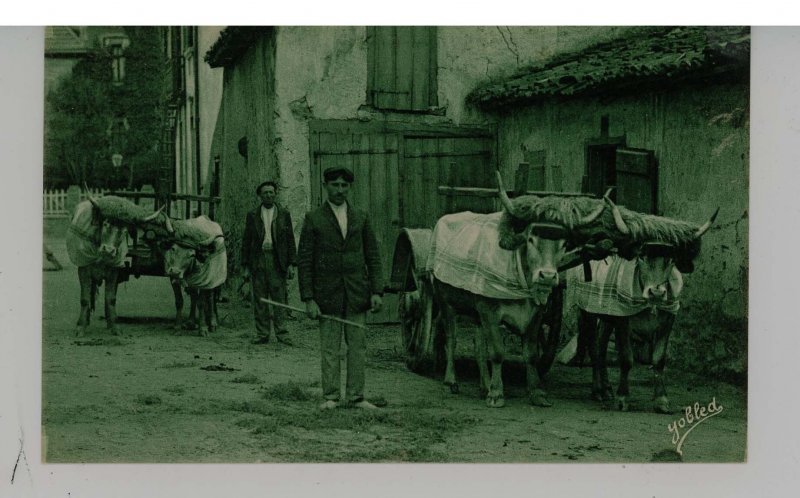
[{"left": 242, "top": 181, "right": 297, "bottom": 345}]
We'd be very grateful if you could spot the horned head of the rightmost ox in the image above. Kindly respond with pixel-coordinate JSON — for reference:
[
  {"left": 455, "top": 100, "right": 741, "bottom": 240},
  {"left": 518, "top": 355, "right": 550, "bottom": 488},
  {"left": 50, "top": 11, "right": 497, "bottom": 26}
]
[{"left": 605, "top": 196, "right": 719, "bottom": 304}]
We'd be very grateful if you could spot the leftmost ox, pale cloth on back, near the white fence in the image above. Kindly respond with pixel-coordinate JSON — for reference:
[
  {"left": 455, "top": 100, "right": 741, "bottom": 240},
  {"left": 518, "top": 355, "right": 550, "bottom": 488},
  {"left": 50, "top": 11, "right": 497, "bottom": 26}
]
[{"left": 66, "top": 196, "right": 166, "bottom": 336}]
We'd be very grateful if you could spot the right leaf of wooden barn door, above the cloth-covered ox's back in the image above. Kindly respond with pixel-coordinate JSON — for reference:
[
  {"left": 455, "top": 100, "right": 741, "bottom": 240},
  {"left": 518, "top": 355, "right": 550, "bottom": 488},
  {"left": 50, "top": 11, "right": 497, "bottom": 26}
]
[{"left": 398, "top": 135, "right": 496, "bottom": 228}]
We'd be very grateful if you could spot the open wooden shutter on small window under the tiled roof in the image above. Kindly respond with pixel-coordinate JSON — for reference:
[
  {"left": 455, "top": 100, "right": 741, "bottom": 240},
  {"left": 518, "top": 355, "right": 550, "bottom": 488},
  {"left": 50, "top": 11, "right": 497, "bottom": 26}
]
[{"left": 616, "top": 147, "right": 658, "bottom": 214}]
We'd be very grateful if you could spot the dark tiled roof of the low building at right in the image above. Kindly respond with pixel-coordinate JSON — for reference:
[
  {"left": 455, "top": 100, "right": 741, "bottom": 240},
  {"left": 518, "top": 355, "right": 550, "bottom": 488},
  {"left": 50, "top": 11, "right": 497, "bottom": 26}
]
[{"left": 467, "top": 26, "right": 750, "bottom": 110}]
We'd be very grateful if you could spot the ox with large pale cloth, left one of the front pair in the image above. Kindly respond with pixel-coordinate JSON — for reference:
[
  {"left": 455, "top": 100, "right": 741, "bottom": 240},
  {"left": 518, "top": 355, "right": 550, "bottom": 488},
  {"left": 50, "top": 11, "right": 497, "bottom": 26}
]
[{"left": 426, "top": 171, "right": 605, "bottom": 408}]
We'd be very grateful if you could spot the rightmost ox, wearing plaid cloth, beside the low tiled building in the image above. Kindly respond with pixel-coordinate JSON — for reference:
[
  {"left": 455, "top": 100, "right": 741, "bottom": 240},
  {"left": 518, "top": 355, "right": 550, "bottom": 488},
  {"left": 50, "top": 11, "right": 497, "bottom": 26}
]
[{"left": 577, "top": 197, "right": 719, "bottom": 413}]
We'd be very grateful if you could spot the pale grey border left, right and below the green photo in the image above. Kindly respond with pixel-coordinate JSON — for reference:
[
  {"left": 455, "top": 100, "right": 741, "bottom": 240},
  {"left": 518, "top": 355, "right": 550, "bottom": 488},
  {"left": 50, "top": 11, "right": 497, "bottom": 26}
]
[{"left": 0, "top": 22, "right": 800, "bottom": 498}]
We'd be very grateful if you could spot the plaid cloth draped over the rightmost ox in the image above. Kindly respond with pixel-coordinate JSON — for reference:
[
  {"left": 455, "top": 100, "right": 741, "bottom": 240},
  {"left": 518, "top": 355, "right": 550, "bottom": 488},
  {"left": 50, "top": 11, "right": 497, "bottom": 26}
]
[{"left": 569, "top": 256, "right": 683, "bottom": 316}]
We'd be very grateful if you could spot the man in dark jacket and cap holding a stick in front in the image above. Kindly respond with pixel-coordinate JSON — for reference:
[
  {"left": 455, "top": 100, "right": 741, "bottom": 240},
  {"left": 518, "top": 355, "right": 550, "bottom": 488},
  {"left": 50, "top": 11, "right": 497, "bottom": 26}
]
[{"left": 297, "top": 168, "right": 383, "bottom": 410}]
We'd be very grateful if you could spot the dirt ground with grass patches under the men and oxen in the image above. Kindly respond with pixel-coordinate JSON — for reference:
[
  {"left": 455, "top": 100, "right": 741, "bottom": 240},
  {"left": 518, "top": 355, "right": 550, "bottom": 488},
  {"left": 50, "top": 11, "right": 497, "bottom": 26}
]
[{"left": 42, "top": 233, "right": 747, "bottom": 463}]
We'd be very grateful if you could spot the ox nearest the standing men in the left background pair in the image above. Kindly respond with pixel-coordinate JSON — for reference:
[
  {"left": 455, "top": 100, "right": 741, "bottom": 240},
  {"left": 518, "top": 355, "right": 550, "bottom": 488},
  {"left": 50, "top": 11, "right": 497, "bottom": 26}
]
[{"left": 164, "top": 216, "right": 228, "bottom": 336}]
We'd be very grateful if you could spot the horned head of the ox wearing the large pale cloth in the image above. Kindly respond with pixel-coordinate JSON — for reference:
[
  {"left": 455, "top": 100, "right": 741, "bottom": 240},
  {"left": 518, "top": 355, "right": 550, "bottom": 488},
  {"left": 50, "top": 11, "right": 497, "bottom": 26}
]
[{"left": 496, "top": 171, "right": 605, "bottom": 305}]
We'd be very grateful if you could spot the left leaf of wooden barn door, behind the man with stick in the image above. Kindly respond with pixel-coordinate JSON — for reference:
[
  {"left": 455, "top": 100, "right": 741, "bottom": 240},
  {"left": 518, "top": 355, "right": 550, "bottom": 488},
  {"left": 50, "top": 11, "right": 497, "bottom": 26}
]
[{"left": 310, "top": 126, "right": 400, "bottom": 323}]
